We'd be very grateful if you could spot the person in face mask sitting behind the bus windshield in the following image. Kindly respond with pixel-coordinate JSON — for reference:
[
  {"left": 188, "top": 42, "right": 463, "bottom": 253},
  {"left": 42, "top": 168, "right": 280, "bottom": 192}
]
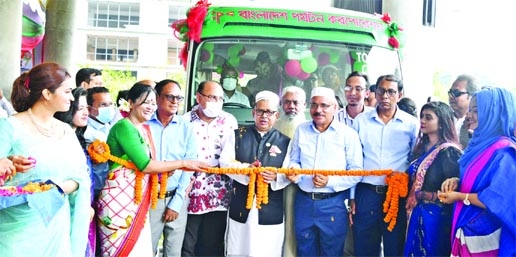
[{"left": 220, "top": 64, "right": 251, "bottom": 107}]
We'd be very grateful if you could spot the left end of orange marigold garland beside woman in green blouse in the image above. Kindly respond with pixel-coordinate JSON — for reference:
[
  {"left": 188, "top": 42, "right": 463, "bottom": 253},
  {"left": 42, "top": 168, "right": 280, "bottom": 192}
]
[{"left": 87, "top": 139, "right": 168, "bottom": 209}]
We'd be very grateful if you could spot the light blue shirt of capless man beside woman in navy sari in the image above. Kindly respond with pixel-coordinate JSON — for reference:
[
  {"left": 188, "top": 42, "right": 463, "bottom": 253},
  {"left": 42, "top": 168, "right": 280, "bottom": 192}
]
[{"left": 353, "top": 109, "right": 419, "bottom": 185}]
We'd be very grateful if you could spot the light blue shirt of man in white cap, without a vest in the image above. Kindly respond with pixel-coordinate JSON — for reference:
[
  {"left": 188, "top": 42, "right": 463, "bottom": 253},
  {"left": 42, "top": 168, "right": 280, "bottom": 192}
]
[{"left": 290, "top": 119, "right": 363, "bottom": 193}]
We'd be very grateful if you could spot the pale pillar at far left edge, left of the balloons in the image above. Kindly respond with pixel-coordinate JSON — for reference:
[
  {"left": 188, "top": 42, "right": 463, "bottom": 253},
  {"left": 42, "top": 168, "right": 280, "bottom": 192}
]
[{"left": 0, "top": 0, "right": 23, "bottom": 99}]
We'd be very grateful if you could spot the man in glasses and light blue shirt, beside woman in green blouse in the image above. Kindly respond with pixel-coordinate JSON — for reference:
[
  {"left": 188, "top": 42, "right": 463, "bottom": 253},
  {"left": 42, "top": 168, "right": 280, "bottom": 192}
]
[{"left": 148, "top": 79, "right": 198, "bottom": 256}]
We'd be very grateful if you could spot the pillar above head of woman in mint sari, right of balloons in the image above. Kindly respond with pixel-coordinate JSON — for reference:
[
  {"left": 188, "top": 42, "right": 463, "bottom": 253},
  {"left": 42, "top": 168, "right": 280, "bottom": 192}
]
[{"left": 43, "top": 0, "right": 77, "bottom": 69}]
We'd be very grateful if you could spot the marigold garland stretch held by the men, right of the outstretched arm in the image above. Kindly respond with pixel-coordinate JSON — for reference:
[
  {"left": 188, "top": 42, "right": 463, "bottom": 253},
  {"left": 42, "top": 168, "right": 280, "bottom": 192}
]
[{"left": 208, "top": 167, "right": 408, "bottom": 231}]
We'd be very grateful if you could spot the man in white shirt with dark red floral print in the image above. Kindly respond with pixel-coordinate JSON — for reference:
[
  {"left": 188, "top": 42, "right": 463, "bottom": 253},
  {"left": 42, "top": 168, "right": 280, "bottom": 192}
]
[{"left": 181, "top": 81, "right": 238, "bottom": 256}]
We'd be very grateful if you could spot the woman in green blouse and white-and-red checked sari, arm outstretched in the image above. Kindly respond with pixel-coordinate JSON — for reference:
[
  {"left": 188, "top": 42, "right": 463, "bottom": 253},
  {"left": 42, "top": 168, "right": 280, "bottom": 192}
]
[{"left": 98, "top": 83, "right": 209, "bottom": 257}]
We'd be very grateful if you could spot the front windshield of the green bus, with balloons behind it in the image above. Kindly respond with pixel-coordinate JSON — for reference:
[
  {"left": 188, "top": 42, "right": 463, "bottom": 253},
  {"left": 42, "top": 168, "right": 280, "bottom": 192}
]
[{"left": 187, "top": 38, "right": 401, "bottom": 122}]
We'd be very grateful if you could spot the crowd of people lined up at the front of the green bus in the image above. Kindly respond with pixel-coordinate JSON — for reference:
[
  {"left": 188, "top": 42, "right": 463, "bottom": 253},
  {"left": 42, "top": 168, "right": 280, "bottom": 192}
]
[{"left": 0, "top": 60, "right": 516, "bottom": 257}]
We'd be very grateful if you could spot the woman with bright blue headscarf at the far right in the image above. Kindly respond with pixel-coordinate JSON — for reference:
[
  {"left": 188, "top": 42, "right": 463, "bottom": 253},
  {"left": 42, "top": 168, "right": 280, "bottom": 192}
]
[{"left": 439, "top": 88, "right": 516, "bottom": 256}]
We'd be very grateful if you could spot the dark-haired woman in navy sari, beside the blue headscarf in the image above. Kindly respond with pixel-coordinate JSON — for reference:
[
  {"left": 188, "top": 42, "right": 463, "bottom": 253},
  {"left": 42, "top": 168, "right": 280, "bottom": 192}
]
[{"left": 405, "top": 102, "right": 462, "bottom": 256}]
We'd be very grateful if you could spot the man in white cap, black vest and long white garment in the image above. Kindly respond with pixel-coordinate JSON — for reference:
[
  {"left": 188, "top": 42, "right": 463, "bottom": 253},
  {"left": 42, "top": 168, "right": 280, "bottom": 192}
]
[{"left": 220, "top": 91, "right": 290, "bottom": 257}]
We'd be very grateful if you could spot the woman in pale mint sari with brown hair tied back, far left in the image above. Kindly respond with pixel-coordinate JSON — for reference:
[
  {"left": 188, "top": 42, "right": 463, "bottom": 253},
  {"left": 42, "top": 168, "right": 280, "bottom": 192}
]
[{"left": 0, "top": 63, "right": 91, "bottom": 257}]
